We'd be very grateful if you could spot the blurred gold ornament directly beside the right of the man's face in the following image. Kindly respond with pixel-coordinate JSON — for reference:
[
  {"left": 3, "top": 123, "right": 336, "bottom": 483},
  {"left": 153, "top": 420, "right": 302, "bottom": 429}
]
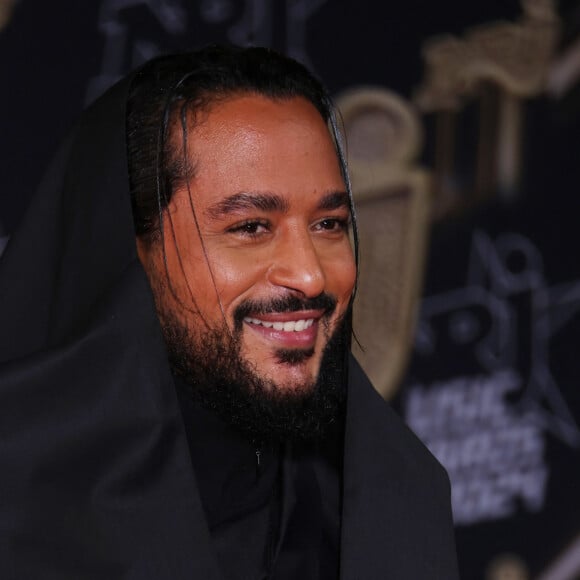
[{"left": 338, "top": 88, "right": 429, "bottom": 398}]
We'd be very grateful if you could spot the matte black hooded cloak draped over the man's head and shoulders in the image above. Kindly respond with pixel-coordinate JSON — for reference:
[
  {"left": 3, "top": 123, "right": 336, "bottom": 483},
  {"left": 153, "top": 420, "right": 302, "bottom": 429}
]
[{"left": 0, "top": 68, "right": 457, "bottom": 580}]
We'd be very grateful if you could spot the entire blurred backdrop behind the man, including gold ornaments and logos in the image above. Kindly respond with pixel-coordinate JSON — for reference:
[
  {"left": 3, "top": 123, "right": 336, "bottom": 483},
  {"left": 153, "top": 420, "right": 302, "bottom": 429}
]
[{"left": 0, "top": 0, "right": 580, "bottom": 580}]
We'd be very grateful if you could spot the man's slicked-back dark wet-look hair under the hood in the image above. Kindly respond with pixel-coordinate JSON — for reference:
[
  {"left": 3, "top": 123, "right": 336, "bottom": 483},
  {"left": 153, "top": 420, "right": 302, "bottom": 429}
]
[{"left": 127, "top": 45, "right": 358, "bottom": 251}]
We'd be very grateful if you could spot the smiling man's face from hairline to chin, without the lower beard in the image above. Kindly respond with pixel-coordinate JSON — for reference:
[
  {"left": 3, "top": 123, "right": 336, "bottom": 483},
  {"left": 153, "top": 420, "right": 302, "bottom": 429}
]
[{"left": 139, "top": 95, "right": 355, "bottom": 402}]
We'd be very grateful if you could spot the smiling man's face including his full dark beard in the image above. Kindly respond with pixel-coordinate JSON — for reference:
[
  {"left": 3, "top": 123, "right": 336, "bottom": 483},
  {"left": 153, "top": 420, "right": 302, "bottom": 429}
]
[{"left": 138, "top": 79, "right": 356, "bottom": 439}]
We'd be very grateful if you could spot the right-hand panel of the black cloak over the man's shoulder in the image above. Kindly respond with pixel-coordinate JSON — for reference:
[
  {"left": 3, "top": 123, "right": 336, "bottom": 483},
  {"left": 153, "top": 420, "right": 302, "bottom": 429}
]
[{"left": 344, "top": 360, "right": 457, "bottom": 580}]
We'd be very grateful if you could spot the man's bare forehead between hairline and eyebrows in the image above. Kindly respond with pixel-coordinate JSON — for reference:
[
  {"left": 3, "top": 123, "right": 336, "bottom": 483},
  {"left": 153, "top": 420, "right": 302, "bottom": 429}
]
[{"left": 172, "top": 94, "right": 344, "bottom": 212}]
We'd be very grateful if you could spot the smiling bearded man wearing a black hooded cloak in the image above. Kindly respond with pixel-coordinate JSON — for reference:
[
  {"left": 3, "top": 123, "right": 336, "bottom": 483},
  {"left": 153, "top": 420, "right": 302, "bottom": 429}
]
[{"left": 0, "top": 47, "right": 457, "bottom": 580}]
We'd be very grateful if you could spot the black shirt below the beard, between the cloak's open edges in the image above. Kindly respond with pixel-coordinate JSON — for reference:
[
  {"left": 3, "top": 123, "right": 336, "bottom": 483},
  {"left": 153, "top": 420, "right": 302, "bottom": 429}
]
[{"left": 176, "top": 379, "right": 342, "bottom": 580}]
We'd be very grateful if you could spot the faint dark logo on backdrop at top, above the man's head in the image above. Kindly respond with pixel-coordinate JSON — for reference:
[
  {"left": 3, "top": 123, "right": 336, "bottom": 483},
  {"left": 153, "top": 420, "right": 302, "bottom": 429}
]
[{"left": 86, "top": 0, "right": 328, "bottom": 102}]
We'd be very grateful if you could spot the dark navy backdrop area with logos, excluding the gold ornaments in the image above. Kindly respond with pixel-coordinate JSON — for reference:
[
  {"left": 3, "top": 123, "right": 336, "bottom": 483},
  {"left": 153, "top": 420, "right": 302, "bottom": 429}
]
[{"left": 0, "top": 0, "right": 580, "bottom": 580}]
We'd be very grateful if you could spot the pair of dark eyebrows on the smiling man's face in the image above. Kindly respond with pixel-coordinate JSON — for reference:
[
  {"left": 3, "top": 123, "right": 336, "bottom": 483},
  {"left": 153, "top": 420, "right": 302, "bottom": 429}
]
[{"left": 205, "top": 191, "right": 350, "bottom": 219}]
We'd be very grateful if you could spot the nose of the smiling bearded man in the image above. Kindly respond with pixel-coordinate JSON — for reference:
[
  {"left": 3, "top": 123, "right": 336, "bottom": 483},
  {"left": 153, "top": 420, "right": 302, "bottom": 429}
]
[{"left": 267, "top": 232, "right": 326, "bottom": 298}]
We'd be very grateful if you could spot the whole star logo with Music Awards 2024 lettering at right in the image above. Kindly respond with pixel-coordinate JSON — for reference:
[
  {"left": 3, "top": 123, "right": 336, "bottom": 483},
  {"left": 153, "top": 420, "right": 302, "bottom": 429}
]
[{"left": 404, "top": 231, "right": 580, "bottom": 524}]
